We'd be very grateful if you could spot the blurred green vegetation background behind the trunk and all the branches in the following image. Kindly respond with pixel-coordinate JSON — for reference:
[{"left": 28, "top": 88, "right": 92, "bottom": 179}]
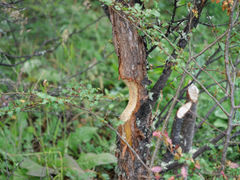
[{"left": 0, "top": 0, "right": 240, "bottom": 180}]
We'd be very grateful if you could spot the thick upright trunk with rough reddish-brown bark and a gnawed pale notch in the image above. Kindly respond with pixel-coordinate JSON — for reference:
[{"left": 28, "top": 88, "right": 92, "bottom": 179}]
[{"left": 109, "top": 3, "right": 151, "bottom": 179}]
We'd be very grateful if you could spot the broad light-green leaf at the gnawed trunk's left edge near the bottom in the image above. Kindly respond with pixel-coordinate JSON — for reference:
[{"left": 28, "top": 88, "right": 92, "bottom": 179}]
[{"left": 78, "top": 153, "right": 117, "bottom": 169}]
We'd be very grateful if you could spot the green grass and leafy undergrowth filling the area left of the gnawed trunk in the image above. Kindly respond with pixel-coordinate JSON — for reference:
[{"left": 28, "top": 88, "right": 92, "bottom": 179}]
[{"left": 0, "top": 1, "right": 120, "bottom": 180}]
